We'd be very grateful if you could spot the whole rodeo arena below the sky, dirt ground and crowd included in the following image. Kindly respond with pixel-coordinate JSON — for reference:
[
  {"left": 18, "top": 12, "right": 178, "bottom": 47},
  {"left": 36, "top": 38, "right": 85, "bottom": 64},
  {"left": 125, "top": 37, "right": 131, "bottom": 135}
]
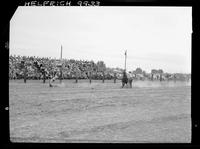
[{"left": 9, "top": 49, "right": 191, "bottom": 143}]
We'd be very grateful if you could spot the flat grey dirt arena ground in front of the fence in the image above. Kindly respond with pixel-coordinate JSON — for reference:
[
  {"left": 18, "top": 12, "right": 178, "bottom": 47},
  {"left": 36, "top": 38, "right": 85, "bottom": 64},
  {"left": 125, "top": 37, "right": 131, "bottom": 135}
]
[{"left": 9, "top": 80, "right": 191, "bottom": 143}]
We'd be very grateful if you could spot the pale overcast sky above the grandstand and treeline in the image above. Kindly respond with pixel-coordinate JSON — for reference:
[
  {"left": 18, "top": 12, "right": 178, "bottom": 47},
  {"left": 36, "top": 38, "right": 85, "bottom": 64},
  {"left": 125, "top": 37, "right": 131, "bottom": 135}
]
[{"left": 9, "top": 6, "right": 192, "bottom": 73}]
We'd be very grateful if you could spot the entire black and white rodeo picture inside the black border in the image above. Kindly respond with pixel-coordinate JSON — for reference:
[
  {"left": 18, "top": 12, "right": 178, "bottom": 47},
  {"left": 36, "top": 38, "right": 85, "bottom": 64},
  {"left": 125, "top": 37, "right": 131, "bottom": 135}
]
[{"left": 9, "top": 6, "right": 192, "bottom": 143}]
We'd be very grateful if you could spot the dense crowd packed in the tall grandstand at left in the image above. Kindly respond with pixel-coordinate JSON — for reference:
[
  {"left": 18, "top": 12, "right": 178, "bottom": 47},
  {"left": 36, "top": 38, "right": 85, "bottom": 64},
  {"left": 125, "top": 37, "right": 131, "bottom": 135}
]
[{"left": 9, "top": 55, "right": 114, "bottom": 79}]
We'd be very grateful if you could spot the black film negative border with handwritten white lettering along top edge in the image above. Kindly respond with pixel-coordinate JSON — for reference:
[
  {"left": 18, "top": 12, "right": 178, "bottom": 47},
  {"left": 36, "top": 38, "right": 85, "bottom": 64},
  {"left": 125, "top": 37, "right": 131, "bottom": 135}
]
[{"left": 0, "top": 0, "right": 200, "bottom": 148}]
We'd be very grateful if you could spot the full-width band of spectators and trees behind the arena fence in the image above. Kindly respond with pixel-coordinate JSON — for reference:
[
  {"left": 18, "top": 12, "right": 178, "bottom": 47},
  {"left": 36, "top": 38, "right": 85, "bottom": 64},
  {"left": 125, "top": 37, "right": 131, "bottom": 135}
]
[{"left": 9, "top": 55, "right": 191, "bottom": 81}]
